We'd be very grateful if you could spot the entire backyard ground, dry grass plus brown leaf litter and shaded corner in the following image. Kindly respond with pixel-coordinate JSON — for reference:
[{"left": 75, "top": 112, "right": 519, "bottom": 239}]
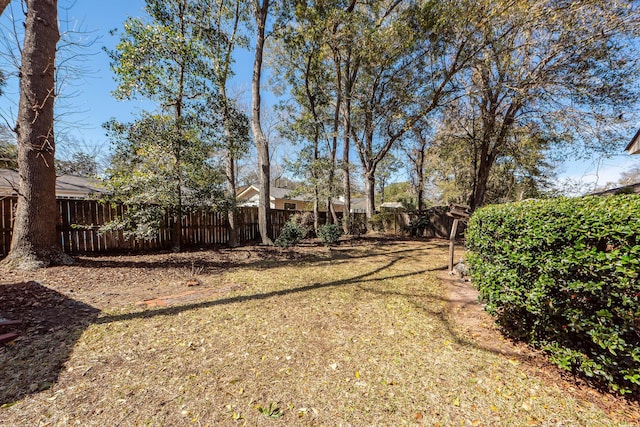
[{"left": 0, "top": 239, "right": 640, "bottom": 426}]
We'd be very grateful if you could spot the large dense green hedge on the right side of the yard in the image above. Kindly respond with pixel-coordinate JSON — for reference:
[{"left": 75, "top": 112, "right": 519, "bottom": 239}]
[{"left": 467, "top": 195, "right": 640, "bottom": 394}]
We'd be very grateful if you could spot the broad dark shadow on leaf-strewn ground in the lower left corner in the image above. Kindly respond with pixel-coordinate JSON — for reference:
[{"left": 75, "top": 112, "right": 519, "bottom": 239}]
[{"left": 0, "top": 282, "right": 99, "bottom": 407}]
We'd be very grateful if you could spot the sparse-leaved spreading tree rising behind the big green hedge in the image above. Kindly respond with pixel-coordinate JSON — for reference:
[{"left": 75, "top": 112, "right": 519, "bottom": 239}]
[{"left": 448, "top": 0, "right": 640, "bottom": 209}]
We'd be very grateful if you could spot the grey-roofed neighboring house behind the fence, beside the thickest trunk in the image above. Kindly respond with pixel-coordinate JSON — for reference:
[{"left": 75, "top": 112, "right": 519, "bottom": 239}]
[{"left": 0, "top": 169, "right": 104, "bottom": 200}]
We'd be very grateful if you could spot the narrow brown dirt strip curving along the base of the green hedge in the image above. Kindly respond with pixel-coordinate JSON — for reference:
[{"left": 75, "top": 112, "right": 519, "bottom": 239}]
[{"left": 438, "top": 271, "right": 640, "bottom": 425}]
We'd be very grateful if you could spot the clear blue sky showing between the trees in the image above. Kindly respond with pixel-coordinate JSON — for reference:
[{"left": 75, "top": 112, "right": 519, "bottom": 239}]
[{"left": 0, "top": 0, "right": 640, "bottom": 191}]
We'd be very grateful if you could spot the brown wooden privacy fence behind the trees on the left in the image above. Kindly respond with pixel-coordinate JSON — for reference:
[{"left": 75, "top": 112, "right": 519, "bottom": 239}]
[{"left": 0, "top": 197, "right": 304, "bottom": 259}]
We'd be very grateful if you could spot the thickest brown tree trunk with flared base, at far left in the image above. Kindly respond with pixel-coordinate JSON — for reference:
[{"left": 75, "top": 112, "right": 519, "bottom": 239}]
[{"left": 3, "top": 0, "right": 73, "bottom": 269}]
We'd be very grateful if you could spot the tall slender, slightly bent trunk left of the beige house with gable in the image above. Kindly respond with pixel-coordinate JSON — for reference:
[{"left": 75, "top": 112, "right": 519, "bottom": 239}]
[{"left": 251, "top": 0, "right": 273, "bottom": 245}]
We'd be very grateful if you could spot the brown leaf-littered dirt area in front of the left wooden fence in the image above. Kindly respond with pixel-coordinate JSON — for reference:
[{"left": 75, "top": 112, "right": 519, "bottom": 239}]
[{"left": 0, "top": 243, "right": 338, "bottom": 310}]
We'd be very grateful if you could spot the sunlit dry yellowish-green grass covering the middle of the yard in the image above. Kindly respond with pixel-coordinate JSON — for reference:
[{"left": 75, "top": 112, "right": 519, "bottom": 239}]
[{"left": 0, "top": 242, "right": 636, "bottom": 426}]
